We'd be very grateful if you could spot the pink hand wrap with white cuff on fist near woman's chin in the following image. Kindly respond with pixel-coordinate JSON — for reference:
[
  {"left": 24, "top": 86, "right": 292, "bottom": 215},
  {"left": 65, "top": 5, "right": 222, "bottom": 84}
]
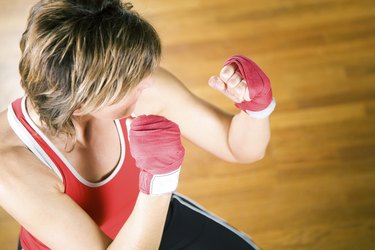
[{"left": 129, "top": 115, "right": 185, "bottom": 195}]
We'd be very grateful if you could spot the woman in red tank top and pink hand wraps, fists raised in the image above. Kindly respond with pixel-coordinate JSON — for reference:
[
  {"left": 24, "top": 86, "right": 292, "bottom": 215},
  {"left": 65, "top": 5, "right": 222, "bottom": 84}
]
[{"left": 0, "top": 0, "right": 275, "bottom": 249}]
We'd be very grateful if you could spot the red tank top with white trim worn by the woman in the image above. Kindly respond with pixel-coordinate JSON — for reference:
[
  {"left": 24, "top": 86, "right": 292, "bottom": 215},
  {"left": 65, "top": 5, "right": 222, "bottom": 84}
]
[{"left": 11, "top": 98, "right": 139, "bottom": 250}]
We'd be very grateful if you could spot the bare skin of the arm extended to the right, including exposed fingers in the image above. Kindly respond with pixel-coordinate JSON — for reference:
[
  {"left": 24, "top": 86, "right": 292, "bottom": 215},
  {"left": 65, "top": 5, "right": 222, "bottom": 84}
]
[{"left": 135, "top": 66, "right": 270, "bottom": 163}]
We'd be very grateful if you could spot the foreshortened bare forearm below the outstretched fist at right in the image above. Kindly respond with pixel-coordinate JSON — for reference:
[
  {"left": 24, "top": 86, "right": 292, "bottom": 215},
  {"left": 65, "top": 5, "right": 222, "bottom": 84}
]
[{"left": 228, "top": 111, "right": 271, "bottom": 163}]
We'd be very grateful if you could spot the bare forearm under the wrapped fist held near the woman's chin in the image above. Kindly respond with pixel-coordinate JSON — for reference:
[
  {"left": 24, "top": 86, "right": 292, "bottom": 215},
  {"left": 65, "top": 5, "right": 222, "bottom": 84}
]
[{"left": 108, "top": 192, "right": 171, "bottom": 250}]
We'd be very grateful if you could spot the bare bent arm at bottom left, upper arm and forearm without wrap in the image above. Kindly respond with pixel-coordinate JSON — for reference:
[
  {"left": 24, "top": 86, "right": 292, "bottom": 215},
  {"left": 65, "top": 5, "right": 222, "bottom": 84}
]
[{"left": 0, "top": 147, "right": 170, "bottom": 250}]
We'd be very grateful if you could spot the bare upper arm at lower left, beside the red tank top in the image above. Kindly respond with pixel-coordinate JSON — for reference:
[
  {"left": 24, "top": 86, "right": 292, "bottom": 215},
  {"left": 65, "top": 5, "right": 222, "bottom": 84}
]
[{"left": 0, "top": 147, "right": 111, "bottom": 249}]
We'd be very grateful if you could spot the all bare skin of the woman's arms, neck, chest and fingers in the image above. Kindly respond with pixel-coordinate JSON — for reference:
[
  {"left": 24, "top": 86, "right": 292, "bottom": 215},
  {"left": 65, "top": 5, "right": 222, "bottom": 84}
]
[{"left": 0, "top": 67, "right": 270, "bottom": 249}]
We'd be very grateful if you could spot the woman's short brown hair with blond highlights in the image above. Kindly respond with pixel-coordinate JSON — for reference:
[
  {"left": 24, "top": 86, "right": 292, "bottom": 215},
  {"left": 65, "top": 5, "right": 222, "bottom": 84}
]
[{"left": 19, "top": 0, "right": 161, "bottom": 136}]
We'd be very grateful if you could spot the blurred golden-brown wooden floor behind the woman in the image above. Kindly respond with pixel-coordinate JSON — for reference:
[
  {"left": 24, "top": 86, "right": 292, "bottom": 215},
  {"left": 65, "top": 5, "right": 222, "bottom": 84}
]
[{"left": 0, "top": 0, "right": 375, "bottom": 250}]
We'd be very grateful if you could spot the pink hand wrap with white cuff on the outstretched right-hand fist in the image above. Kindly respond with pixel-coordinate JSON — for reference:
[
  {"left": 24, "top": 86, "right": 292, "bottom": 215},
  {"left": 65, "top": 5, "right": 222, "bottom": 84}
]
[{"left": 224, "top": 55, "right": 276, "bottom": 119}]
